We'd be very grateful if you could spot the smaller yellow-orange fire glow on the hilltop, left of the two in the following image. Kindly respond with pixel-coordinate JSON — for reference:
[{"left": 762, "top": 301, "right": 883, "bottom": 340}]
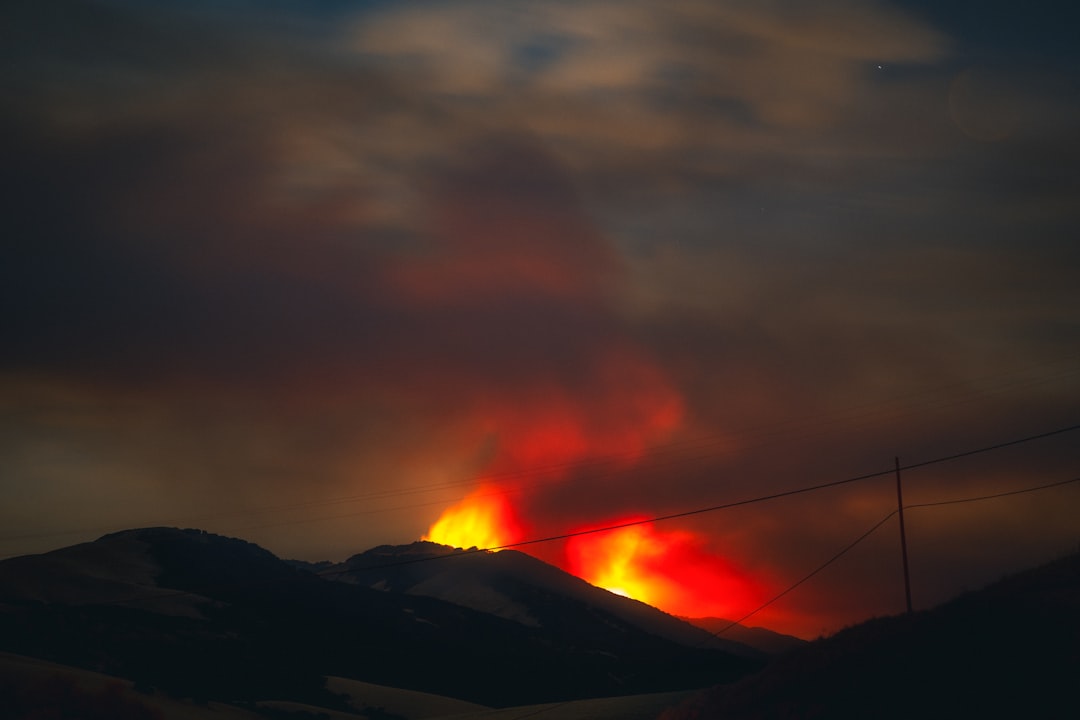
[{"left": 421, "top": 488, "right": 523, "bottom": 547}]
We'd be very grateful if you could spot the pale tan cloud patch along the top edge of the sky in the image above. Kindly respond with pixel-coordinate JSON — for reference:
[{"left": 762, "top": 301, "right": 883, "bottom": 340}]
[{"left": 355, "top": 0, "right": 945, "bottom": 149}]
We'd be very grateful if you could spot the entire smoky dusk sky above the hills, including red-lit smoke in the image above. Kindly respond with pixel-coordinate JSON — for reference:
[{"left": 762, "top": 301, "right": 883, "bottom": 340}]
[{"left": 0, "top": 0, "right": 1080, "bottom": 637}]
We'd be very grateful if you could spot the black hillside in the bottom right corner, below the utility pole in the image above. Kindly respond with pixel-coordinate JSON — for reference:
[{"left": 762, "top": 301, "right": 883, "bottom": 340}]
[{"left": 663, "top": 554, "right": 1080, "bottom": 720}]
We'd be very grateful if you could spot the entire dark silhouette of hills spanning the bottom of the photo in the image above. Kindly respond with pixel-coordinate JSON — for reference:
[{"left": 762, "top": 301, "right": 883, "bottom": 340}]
[{"left": 0, "top": 528, "right": 1080, "bottom": 720}]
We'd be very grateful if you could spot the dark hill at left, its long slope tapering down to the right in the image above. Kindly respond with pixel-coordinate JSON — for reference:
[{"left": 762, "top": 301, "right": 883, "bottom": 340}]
[{"left": 0, "top": 528, "right": 760, "bottom": 707}]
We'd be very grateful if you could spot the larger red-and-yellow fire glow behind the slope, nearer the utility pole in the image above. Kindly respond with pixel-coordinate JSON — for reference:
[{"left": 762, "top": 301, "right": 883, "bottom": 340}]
[{"left": 566, "top": 518, "right": 762, "bottom": 617}]
